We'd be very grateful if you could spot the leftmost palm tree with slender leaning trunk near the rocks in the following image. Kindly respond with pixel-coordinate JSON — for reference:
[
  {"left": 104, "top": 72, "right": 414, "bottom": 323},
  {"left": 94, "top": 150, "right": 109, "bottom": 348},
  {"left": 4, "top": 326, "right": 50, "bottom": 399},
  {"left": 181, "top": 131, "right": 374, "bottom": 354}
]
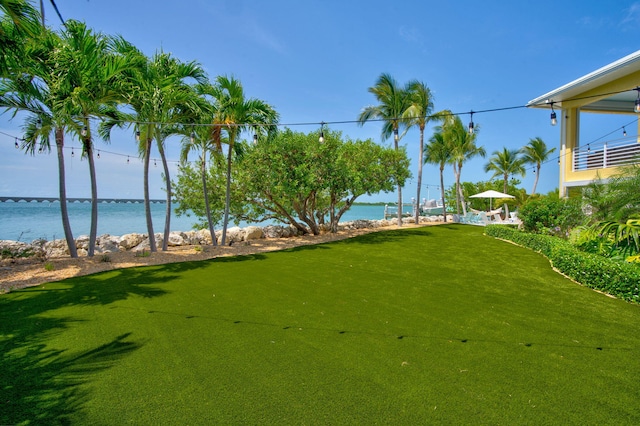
[{"left": 0, "top": 23, "right": 78, "bottom": 258}]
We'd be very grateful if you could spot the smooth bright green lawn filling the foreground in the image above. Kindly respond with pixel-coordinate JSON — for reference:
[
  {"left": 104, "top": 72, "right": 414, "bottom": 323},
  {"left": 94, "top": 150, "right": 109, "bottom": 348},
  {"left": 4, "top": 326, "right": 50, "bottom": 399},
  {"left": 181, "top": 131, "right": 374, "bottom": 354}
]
[{"left": 0, "top": 225, "right": 640, "bottom": 425}]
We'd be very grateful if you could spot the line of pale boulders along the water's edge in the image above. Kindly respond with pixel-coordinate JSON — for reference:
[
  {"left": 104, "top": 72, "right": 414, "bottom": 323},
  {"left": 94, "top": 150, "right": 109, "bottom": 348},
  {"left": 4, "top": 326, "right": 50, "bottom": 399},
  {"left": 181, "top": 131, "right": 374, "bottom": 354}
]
[{"left": 0, "top": 216, "right": 443, "bottom": 259}]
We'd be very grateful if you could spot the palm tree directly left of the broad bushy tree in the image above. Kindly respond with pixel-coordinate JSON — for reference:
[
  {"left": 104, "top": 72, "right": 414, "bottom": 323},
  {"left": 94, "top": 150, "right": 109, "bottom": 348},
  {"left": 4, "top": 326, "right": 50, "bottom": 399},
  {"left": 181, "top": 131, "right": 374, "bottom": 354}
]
[{"left": 202, "top": 76, "right": 278, "bottom": 245}]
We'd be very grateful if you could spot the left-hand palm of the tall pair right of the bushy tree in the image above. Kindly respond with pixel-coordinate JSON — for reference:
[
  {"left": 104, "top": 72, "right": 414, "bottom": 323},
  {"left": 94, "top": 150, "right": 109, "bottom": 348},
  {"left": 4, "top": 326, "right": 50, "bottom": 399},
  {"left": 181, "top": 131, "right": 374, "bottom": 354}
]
[{"left": 358, "top": 73, "right": 411, "bottom": 226}]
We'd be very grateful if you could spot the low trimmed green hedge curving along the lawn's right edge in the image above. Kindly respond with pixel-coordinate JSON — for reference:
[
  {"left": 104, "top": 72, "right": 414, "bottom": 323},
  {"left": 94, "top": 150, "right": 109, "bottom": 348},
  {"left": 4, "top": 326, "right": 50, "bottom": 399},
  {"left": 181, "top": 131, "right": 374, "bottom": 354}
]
[{"left": 485, "top": 225, "right": 640, "bottom": 302}]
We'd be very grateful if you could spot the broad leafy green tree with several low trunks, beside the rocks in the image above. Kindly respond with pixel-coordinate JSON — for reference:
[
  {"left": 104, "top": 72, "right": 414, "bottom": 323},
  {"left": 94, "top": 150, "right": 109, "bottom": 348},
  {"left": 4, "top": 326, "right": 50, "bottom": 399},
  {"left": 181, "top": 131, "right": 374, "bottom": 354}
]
[{"left": 238, "top": 129, "right": 410, "bottom": 234}]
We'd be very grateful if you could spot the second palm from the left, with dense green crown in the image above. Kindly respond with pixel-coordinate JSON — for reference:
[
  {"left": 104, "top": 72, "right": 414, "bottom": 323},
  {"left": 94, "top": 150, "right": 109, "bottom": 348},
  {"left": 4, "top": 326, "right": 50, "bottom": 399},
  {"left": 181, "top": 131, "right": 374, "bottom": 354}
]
[{"left": 56, "top": 20, "right": 129, "bottom": 257}]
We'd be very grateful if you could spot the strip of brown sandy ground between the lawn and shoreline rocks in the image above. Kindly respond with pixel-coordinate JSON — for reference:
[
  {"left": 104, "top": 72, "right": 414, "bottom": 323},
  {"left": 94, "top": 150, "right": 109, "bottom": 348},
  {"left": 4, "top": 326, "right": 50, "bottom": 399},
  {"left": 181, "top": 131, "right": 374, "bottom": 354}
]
[{"left": 0, "top": 224, "right": 425, "bottom": 293}]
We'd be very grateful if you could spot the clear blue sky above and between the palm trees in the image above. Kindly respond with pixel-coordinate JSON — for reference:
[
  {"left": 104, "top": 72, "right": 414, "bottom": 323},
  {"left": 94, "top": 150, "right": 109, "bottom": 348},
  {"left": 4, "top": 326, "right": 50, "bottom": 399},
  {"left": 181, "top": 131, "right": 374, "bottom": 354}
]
[{"left": 0, "top": 0, "right": 640, "bottom": 202}]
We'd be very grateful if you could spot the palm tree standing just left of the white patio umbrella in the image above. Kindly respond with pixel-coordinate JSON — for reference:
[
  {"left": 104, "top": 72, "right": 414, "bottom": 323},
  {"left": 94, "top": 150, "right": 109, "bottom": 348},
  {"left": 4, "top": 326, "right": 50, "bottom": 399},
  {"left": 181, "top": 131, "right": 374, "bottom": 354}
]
[{"left": 443, "top": 115, "right": 486, "bottom": 215}]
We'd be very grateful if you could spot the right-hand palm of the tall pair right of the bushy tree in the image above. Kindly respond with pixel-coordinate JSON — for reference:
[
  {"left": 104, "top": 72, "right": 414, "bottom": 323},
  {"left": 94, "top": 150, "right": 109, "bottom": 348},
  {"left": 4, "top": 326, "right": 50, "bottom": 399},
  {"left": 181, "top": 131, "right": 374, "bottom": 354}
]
[{"left": 404, "top": 80, "right": 436, "bottom": 225}]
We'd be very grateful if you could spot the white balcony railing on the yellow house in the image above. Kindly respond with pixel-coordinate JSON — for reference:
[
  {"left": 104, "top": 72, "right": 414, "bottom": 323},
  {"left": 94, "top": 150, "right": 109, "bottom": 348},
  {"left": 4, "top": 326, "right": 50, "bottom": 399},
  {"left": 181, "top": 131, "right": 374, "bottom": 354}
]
[{"left": 573, "top": 140, "right": 640, "bottom": 171}]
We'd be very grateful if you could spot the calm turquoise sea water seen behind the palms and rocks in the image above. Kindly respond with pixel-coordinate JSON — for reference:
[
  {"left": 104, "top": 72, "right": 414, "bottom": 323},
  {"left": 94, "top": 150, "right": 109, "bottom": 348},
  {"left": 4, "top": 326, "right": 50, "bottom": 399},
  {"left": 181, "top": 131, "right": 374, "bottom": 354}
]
[{"left": 0, "top": 202, "right": 411, "bottom": 242}]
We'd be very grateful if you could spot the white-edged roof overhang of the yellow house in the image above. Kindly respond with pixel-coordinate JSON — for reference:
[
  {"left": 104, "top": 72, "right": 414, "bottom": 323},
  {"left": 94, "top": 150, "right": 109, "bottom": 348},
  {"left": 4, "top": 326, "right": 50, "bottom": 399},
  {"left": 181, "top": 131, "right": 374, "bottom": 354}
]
[{"left": 527, "top": 50, "right": 640, "bottom": 113}]
